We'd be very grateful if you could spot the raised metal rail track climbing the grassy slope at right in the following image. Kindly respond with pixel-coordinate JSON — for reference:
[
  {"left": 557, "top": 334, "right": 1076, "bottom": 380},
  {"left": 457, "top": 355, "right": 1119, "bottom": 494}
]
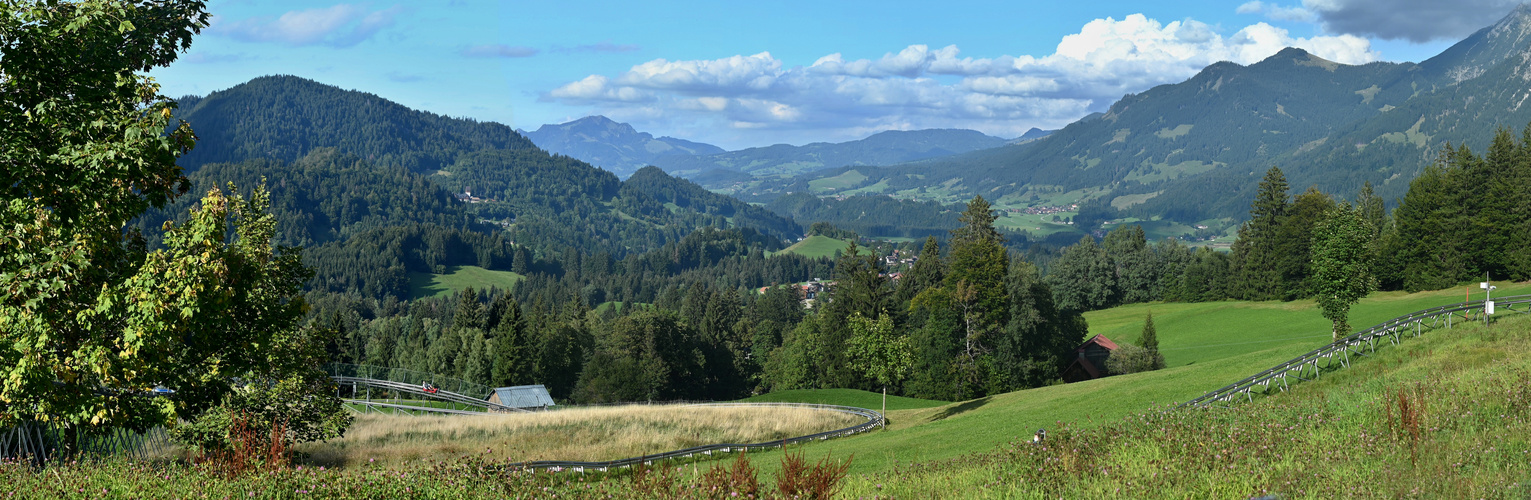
[{"left": 1176, "top": 295, "right": 1531, "bottom": 408}]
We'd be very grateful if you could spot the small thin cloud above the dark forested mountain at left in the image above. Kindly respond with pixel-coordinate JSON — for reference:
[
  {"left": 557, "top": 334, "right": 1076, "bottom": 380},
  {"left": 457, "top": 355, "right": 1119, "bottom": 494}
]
[{"left": 217, "top": 3, "right": 404, "bottom": 47}]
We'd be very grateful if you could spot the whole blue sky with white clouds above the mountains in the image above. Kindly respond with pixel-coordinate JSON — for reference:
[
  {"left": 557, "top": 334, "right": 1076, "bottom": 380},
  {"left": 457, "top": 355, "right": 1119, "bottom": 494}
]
[{"left": 153, "top": 0, "right": 1514, "bottom": 150}]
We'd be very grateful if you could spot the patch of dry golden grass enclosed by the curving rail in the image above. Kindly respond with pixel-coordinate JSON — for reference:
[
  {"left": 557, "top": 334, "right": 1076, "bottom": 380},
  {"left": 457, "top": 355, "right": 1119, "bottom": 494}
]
[{"left": 300, "top": 405, "right": 860, "bottom": 465}]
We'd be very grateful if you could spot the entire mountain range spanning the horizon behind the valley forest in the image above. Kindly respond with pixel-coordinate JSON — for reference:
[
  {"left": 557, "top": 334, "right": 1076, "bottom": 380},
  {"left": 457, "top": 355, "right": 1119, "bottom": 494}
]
[{"left": 176, "top": 6, "right": 1531, "bottom": 255}]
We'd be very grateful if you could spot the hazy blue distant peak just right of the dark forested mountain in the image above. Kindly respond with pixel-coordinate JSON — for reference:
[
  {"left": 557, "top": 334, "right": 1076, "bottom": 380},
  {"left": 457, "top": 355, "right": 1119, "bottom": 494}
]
[{"left": 525, "top": 115, "right": 723, "bottom": 177}]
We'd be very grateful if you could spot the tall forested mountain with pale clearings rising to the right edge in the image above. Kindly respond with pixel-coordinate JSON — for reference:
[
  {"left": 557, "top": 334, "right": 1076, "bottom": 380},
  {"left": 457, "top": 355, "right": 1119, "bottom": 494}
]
[{"left": 756, "top": 6, "right": 1531, "bottom": 222}]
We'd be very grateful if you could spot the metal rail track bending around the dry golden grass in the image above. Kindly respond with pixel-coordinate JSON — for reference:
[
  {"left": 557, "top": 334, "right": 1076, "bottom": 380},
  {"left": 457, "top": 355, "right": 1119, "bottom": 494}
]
[{"left": 508, "top": 402, "right": 882, "bottom": 472}]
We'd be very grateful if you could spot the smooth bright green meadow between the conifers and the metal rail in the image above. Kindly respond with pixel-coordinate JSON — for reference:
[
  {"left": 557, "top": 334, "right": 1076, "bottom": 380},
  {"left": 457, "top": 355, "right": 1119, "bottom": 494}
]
[{"left": 731, "top": 283, "right": 1531, "bottom": 477}]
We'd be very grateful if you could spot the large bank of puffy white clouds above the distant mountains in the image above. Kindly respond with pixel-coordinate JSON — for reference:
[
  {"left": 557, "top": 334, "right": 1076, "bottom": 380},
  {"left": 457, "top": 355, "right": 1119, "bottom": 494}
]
[{"left": 544, "top": 14, "right": 1378, "bottom": 142}]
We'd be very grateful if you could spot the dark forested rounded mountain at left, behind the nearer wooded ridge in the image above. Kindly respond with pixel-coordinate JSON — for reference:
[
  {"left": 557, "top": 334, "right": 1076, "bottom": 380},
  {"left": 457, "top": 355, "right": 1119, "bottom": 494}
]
[{"left": 176, "top": 76, "right": 536, "bottom": 173}]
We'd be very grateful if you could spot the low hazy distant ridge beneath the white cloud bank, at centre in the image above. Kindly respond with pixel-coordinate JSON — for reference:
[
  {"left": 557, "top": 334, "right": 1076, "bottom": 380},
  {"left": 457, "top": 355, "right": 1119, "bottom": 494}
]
[{"left": 654, "top": 128, "right": 1004, "bottom": 181}]
